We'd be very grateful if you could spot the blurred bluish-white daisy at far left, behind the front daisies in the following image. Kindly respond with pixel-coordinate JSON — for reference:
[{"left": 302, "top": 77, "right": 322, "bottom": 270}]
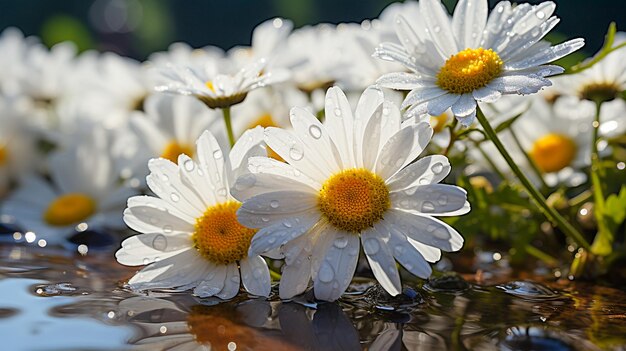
[{"left": 0, "top": 129, "right": 135, "bottom": 246}]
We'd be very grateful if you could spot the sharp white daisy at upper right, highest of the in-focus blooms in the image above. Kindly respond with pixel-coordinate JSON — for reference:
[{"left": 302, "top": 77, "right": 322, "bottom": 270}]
[{"left": 374, "top": 0, "right": 584, "bottom": 126}]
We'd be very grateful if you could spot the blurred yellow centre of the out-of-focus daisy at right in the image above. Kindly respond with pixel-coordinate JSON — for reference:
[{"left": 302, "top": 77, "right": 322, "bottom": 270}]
[{"left": 530, "top": 133, "right": 576, "bottom": 173}]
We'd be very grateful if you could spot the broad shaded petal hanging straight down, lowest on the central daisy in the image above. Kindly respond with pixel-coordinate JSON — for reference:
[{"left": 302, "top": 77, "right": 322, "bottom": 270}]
[{"left": 313, "top": 232, "right": 359, "bottom": 301}]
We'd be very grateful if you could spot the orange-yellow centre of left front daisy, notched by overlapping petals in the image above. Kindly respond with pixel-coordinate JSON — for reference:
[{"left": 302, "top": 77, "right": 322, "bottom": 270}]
[{"left": 191, "top": 201, "right": 256, "bottom": 265}]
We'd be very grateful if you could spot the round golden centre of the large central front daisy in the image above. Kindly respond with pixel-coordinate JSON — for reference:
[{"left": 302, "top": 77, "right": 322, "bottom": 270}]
[{"left": 318, "top": 168, "right": 391, "bottom": 234}]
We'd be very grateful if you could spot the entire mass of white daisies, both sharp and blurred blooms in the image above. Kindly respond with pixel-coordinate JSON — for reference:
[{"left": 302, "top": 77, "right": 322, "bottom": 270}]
[{"left": 0, "top": 0, "right": 626, "bottom": 301}]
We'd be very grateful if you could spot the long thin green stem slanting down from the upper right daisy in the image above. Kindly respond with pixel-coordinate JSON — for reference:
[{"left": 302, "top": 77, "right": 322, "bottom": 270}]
[{"left": 476, "top": 108, "right": 591, "bottom": 250}]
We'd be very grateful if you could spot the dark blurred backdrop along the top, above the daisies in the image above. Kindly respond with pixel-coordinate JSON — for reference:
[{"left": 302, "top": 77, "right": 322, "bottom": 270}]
[{"left": 0, "top": 0, "right": 626, "bottom": 60}]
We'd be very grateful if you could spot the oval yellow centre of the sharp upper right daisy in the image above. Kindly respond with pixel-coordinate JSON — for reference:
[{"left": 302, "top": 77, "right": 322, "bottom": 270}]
[{"left": 437, "top": 48, "right": 503, "bottom": 94}]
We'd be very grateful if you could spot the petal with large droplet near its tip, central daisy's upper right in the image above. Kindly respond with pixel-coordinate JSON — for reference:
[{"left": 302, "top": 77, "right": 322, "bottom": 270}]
[{"left": 387, "top": 155, "right": 451, "bottom": 191}]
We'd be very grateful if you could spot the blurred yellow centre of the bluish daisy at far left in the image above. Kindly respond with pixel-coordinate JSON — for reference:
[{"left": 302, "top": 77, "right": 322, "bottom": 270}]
[{"left": 43, "top": 193, "right": 96, "bottom": 227}]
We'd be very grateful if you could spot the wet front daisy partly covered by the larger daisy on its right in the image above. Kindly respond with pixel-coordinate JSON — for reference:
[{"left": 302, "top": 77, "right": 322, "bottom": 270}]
[{"left": 115, "top": 127, "right": 270, "bottom": 299}]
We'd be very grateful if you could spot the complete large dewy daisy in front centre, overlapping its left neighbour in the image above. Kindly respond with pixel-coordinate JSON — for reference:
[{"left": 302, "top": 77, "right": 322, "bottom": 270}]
[{"left": 232, "top": 87, "right": 469, "bottom": 301}]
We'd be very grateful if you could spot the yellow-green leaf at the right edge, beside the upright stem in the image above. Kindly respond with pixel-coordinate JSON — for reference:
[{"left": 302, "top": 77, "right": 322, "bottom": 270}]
[{"left": 591, "top": 185, "right": 626, "bottom": 256}]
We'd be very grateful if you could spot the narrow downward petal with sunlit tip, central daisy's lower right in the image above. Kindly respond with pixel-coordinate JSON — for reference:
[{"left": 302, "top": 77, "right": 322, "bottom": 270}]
[{"left": 361, "top": 228, "right": 402, "bottom": 296}]
